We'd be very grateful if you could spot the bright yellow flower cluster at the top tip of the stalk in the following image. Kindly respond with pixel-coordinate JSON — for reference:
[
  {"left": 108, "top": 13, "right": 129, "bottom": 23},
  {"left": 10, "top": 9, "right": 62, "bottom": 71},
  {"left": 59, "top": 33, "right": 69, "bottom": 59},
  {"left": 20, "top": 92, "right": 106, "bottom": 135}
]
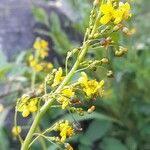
[{"left": 100, "top": 0, "right": 131, "bottom": 25}]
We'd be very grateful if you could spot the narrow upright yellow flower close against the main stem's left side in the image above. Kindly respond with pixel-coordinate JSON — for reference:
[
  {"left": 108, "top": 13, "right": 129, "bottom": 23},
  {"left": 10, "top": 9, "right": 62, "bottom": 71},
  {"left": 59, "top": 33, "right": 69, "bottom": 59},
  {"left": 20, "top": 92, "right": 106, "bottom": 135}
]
[{"left": 52, "top": 67, "right": 64, "bottom": 87}]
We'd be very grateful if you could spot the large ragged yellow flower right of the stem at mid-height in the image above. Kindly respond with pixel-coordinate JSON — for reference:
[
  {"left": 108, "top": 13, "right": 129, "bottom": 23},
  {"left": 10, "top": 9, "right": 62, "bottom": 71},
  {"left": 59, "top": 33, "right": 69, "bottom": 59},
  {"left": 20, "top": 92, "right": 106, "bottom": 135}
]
[{"left": 78, "top": 72, "right": 104, "bottom": 97}]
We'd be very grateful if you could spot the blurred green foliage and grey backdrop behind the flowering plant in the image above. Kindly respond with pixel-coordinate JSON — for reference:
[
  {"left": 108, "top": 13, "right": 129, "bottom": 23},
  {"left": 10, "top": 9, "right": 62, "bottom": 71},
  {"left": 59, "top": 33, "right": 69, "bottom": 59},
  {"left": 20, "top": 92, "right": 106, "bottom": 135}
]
[{"left": 0, "top": 0, "right": 150, "bottom": 150}]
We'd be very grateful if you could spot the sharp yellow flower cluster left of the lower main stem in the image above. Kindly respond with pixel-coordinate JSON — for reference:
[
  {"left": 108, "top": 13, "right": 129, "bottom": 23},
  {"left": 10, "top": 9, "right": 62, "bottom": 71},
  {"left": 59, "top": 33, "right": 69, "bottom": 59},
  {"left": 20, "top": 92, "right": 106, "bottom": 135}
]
[{"left": 16, "top": 95, "right": 38, "bottom": 117}]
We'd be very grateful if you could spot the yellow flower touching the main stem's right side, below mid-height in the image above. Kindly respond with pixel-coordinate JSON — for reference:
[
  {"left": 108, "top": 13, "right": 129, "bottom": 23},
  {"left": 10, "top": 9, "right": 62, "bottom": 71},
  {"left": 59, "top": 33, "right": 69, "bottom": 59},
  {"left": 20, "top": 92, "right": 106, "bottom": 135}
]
[{"left": 58, "top": 88, "right": 75, "bottom": 109}]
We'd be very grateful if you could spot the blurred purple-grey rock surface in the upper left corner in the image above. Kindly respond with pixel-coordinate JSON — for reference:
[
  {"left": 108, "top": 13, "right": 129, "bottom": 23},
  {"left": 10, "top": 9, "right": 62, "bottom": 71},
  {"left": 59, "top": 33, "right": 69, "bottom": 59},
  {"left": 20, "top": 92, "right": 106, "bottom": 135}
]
[{"left": 0, "top": 0, "right": 34, "bottom": 58}]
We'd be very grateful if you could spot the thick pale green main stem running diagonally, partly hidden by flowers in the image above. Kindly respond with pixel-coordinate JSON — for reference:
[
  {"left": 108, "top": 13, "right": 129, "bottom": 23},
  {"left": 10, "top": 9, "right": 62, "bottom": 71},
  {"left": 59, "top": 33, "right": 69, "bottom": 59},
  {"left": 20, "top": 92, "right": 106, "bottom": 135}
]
[{"left": 21, "top": 9, "right": 100, "bottom": 150}]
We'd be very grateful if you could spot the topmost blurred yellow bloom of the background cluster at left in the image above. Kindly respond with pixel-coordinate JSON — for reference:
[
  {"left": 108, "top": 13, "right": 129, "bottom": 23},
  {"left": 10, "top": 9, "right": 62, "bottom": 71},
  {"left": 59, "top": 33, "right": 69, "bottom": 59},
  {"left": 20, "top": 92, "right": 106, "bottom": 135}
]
[{"left": 33, "top": 38, "right": 48, "bottom": 50}]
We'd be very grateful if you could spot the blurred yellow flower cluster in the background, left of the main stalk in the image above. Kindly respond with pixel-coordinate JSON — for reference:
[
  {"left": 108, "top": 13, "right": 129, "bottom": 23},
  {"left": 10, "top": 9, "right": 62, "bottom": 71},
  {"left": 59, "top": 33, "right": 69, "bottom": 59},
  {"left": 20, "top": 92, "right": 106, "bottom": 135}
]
[{"left": 28, "top": 38, "right": 53, "bottom": 72}]
